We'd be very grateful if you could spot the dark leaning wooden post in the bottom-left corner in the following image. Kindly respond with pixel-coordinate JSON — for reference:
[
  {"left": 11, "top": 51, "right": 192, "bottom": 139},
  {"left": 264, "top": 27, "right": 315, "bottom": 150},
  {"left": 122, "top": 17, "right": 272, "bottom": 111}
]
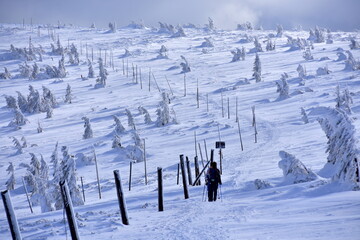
[{"left": 1, "top": 190, "right": 21, "bottom": 240}]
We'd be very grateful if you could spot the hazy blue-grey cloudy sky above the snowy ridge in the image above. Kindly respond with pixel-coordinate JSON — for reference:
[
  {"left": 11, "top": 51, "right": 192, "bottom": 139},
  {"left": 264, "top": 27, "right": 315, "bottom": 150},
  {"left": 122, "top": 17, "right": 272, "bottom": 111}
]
[{"left": 0, "top": 0, "right": 360, "bottom": 31}]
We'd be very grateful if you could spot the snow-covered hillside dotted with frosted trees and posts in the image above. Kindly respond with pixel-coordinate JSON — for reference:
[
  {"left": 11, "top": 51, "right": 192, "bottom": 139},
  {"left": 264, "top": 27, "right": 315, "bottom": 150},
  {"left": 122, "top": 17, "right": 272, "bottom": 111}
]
[{"left": 0, "top": 21, "right": 360, "bottom": 240}]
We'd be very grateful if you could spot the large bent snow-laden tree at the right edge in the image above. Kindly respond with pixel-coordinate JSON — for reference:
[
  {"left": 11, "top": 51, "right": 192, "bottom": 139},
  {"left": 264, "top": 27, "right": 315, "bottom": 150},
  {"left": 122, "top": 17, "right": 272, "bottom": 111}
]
[{"left": 318, "top": 108, "right": 360, "bottom": 187}]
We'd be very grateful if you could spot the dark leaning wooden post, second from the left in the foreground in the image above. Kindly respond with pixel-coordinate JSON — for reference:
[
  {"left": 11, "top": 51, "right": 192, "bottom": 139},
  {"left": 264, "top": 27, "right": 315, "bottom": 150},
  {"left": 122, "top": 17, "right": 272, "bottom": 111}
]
[{"left": 59, "top": 181, "right": 80, "bottom": 240}]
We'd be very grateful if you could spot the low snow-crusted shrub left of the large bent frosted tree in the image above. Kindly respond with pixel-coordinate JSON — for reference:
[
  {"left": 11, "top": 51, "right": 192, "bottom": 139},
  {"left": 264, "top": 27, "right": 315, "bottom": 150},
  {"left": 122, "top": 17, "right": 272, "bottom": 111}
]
[{"left": 279, "top": 151, "right": 318, "bottom": 184}]
